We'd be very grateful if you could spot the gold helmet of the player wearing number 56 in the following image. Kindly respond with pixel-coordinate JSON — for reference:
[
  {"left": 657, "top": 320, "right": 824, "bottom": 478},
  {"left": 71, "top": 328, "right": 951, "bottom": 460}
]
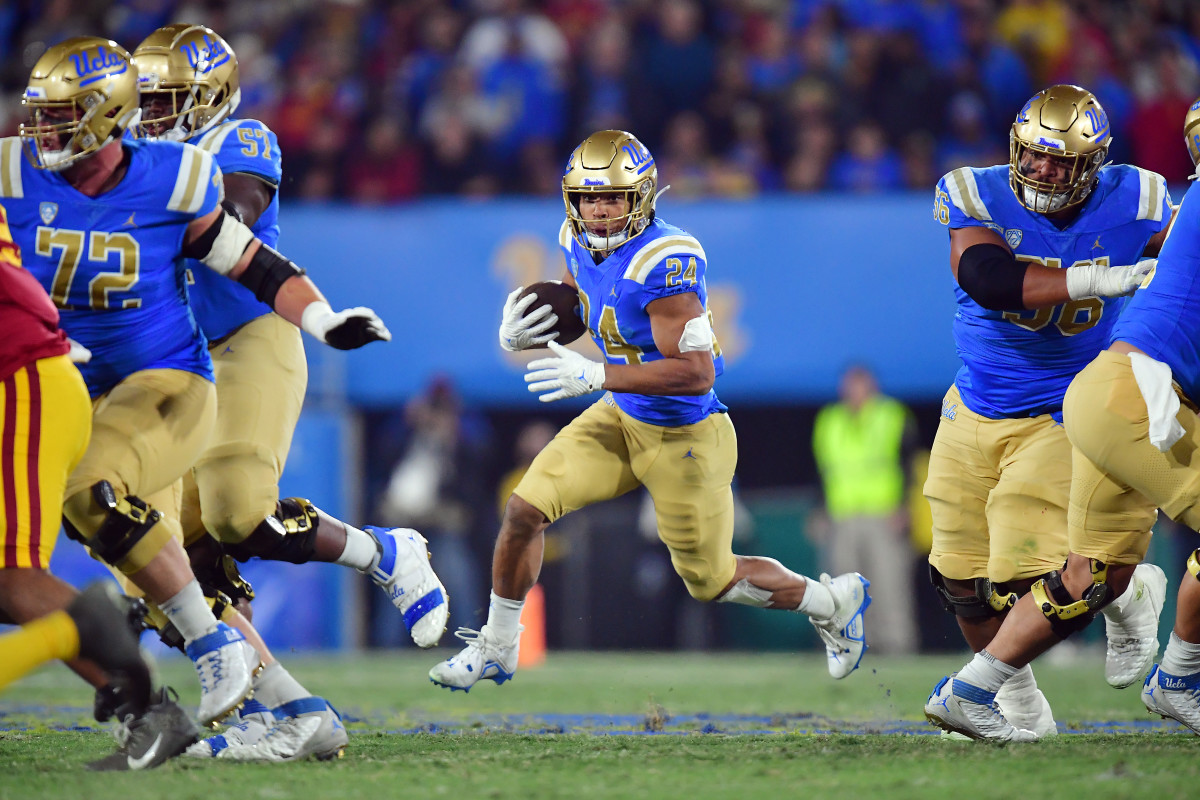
[{"left": 1008, "top": 84, "right": 1112, "bottom": 213}]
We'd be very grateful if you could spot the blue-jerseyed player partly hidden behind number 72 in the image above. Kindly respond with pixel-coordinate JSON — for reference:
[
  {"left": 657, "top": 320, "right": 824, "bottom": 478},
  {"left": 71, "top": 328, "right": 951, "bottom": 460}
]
[{"left": 133, "top": 17, "right": 448, "bottom": 681}]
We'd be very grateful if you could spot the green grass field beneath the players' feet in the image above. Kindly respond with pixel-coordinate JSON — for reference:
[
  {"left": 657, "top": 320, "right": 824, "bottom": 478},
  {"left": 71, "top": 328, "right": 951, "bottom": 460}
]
[{"left": 0, "top": 650, "right": 1200, "bottom": 800}]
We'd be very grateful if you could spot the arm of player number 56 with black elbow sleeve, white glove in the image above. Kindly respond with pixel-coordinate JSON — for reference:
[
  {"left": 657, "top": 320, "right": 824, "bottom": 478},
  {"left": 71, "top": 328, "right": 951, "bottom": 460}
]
[{"left": 950, "top": 225, "right": 1150, "bottom": 311}]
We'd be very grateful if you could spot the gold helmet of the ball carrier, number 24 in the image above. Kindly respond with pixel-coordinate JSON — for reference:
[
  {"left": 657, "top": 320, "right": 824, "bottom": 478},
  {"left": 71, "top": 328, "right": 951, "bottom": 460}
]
[{"left": 563, "top": 131, "right": 659, "bottom": 253}]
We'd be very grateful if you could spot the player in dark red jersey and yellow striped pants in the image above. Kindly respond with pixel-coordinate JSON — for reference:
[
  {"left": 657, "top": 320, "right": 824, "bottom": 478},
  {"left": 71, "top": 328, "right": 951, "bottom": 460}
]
[{"left": 0, "top": 206, "right": 196, "bottom": 769}]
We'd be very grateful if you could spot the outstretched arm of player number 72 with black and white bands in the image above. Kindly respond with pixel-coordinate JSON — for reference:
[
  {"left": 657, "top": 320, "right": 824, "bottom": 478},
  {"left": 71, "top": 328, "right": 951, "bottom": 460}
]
[{"left": 182, "top": 206, "right": 391, "bottom": 350}]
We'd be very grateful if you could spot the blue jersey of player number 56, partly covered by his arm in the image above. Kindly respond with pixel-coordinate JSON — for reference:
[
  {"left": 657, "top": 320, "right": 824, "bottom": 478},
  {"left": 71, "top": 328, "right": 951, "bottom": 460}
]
[{"left": 934, "top": 164, "right": 1171, "bottom": 421}]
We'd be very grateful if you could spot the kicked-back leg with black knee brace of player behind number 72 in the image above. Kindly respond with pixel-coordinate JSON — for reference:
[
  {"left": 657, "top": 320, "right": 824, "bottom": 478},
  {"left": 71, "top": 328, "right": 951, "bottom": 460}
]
[{"left": 184, "top": 314, "right": 449, "bottom": 648}]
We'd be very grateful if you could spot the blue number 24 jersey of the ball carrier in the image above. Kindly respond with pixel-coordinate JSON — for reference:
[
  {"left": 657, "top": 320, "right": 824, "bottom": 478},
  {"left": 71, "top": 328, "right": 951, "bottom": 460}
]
[{"left": 558, "top": 212, "right": 727, "bottom": 427}]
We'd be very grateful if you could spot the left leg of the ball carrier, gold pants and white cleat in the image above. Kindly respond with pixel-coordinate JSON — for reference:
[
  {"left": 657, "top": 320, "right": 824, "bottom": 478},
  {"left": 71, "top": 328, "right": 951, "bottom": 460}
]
[{"left": 430, "top": 396, "right": 638, "bottom": 691}]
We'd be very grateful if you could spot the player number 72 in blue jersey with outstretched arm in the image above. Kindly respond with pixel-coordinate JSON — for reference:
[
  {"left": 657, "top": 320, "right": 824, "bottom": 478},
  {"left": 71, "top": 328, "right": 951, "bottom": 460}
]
[{"left": 0, "top": 37, "right": 390, "bottom": 724}]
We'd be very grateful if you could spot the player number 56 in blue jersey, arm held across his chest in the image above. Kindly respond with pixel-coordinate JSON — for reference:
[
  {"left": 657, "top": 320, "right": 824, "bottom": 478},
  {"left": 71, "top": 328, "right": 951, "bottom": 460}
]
[{"left": 925, "top": 85, "right": 1172, "bottom": 739}]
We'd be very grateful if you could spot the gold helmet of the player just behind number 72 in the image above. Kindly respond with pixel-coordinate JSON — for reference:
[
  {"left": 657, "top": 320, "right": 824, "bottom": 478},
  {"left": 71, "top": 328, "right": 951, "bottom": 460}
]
[{"left": 133, "top": 23, "right": 241, "bottom": 142}]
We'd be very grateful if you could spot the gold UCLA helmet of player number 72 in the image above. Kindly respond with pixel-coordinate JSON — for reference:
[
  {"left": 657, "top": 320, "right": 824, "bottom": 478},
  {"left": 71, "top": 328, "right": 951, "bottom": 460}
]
[{"left": 18, "top": 36, "right": 138, "bottom": 172}]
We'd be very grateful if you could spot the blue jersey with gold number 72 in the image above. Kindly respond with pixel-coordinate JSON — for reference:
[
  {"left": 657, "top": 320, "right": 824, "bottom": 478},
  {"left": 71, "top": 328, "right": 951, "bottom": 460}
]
[{"left": 0, "top": 138, "right": 228, "bottom": 397}]
